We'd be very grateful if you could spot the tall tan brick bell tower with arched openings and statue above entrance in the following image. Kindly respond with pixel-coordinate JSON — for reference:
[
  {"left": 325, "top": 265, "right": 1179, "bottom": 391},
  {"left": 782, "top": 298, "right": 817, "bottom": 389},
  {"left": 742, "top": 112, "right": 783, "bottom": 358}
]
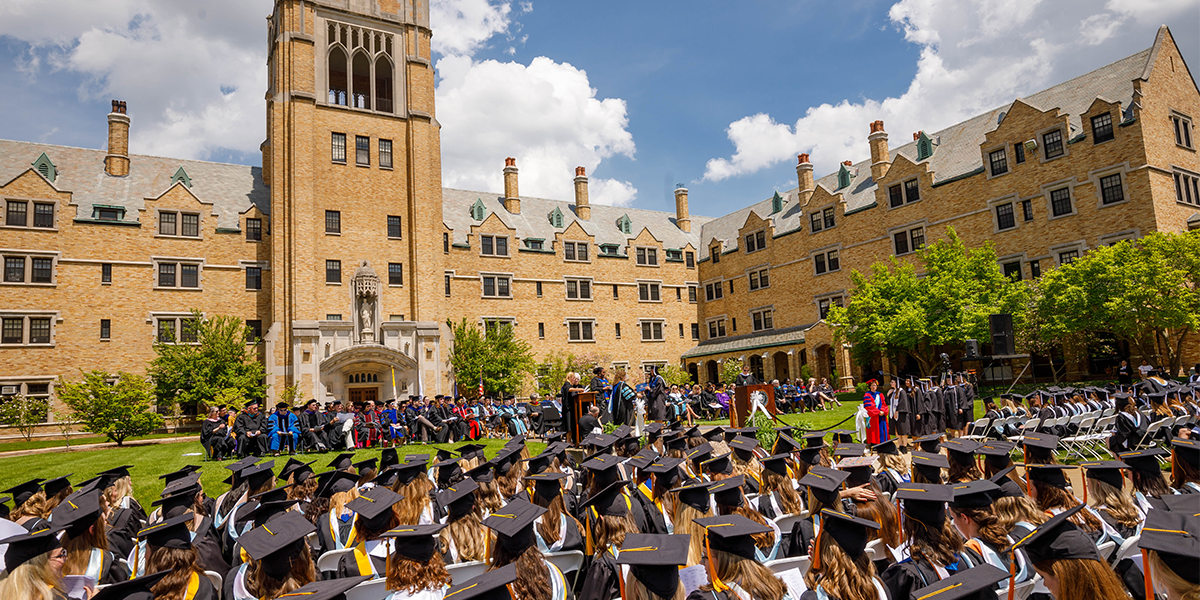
[{"left": 262, "top": 0, "right": 443, "bottom": 401}]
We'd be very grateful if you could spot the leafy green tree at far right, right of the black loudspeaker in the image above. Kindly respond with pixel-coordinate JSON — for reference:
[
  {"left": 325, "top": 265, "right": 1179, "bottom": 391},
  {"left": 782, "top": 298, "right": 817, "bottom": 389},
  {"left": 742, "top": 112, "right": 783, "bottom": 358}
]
[{"left": 1022, "top": 232, "right": 1200, "bottom": 374}]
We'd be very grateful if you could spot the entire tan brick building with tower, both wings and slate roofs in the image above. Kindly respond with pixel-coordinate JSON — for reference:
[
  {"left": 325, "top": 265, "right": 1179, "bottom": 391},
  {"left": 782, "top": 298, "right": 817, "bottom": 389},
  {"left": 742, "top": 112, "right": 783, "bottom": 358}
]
[{"left": 0, "top": 0, "right": 1200, "bottom": 436}]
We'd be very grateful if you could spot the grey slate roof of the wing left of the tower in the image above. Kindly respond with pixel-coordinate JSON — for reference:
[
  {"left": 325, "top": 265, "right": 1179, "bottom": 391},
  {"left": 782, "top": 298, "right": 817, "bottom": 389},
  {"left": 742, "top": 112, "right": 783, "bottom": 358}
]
[{"left": 0, "top": 139, "right": 271, "bottom": 229}]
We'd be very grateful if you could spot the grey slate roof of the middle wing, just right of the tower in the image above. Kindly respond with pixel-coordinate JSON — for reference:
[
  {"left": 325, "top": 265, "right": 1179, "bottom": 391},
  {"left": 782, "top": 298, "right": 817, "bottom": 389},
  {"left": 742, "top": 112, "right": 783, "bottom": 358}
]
[{"left": 442, "top": 187, "right": 712, "bottom": 253}]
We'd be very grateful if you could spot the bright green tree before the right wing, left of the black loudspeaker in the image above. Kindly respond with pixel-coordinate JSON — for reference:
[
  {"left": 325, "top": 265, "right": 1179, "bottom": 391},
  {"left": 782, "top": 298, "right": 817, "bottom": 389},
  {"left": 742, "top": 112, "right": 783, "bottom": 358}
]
[{"left": 826, "top": 227, "right": 1027, "bottom": 374}]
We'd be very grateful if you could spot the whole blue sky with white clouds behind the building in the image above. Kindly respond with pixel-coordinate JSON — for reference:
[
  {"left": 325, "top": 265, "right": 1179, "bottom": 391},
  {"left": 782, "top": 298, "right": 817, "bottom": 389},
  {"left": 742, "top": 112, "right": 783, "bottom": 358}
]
[{"left": 0, "top": 0, "right": 1200, "bottom": 216}]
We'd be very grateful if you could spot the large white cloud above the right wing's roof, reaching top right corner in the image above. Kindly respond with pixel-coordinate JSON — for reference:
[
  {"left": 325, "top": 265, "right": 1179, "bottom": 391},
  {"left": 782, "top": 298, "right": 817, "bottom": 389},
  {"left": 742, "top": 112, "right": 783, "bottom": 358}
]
[{"left": 703, "top": 0, "right": 1196, "bottom": 181}]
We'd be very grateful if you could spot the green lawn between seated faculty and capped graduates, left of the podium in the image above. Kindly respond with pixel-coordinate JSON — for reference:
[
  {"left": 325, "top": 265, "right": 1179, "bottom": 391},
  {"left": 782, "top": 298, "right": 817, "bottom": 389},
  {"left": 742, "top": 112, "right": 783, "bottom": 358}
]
[{"left": 0, "top": 439, "right": 546, "bottom": 512}]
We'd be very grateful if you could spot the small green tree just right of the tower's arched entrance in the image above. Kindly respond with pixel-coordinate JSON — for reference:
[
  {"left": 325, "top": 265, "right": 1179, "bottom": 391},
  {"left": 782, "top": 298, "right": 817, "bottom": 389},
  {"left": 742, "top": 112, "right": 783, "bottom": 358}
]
[{"left": 446, "top": 318, "right": 534, "bottom": 397}]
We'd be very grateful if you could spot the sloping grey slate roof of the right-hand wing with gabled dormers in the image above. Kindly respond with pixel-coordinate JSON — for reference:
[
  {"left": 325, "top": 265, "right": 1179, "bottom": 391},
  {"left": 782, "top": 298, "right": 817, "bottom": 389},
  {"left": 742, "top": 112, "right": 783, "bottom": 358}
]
[{"left": 700, "top": 43, "right": 1162, "bottom": 258}]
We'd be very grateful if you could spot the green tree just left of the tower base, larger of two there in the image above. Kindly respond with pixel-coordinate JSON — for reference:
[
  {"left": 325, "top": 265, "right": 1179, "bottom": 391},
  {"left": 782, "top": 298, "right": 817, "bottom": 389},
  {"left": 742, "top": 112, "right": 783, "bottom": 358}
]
[{"left": 149, "top": 310, "right": 266, "bottom": 409}]
